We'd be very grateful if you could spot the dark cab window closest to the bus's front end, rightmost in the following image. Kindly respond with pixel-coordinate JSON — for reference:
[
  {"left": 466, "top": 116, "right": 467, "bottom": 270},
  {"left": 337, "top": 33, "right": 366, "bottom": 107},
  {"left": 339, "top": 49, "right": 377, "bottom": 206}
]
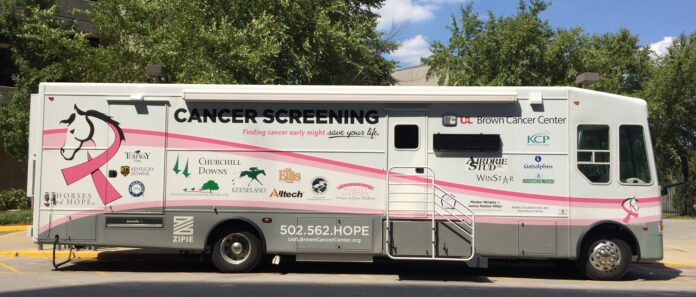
[{"left": 619, "top": 125, "right": 652, "bottom": 185}]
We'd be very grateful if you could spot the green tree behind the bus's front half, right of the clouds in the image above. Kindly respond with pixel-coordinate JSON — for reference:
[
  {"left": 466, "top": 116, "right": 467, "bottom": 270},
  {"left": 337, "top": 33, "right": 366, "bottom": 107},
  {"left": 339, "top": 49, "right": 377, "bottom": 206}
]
[{"left": 422, "top": 0, "right": 651, "bottom": 94}]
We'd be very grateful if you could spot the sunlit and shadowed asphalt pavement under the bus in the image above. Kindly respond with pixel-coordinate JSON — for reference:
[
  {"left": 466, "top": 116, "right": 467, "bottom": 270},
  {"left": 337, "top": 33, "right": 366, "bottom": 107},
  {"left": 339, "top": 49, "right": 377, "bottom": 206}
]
[{"left": 0, "top": 254, "right": 696, "bottom": 297}]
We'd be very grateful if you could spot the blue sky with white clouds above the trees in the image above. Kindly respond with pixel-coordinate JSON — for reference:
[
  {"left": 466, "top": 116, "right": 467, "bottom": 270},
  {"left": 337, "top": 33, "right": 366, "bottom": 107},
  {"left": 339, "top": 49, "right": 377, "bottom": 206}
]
[{"left": 377, "top": 0, "right": 696, "bottom": 68}]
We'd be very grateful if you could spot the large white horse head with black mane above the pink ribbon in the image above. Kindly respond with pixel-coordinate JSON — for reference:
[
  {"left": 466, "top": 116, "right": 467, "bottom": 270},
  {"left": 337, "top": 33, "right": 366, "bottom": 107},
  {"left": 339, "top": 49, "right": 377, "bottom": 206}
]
[{"left": 60, "top": 105, "right": 126, "bottom": 161}]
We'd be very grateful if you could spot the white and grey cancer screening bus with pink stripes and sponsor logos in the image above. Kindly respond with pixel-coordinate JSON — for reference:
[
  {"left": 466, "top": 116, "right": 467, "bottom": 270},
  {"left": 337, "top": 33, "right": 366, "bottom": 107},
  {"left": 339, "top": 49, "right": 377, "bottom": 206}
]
[{"left": 27, "top": 83, "right": 662, "bottom": 279}]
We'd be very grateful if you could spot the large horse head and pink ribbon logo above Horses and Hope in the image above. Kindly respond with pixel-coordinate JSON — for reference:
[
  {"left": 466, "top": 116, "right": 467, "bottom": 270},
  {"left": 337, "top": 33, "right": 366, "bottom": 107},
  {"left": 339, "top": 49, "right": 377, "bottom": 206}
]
[{"left": 60, "top": 105, "right": 126, "bottom": 204}]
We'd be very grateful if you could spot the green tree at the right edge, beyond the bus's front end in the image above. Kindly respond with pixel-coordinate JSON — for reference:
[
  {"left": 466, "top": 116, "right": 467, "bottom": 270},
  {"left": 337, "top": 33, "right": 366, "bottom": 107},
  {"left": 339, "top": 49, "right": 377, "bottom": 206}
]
[{"left": 642, "top": 33, "right": 696, "bottom": 181}]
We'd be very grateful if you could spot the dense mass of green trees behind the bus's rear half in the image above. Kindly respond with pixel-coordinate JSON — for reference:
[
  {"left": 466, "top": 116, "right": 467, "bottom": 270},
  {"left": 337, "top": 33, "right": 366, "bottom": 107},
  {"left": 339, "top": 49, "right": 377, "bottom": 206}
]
[{"left": 0, "top": 0, "right": 397, "bottom": 164}]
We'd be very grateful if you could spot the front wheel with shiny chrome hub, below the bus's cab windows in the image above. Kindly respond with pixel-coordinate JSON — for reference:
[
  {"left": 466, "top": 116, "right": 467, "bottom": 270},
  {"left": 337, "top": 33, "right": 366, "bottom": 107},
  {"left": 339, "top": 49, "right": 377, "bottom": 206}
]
[{"left": 577, "top": 236, "right": 632, "bottom": 280}]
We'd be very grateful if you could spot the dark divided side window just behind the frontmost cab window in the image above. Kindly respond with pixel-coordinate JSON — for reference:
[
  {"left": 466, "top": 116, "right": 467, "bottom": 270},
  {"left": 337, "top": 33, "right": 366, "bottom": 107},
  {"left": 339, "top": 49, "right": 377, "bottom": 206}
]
[{"left": 578, "top": 125, "right": 610, "bottom": 183}]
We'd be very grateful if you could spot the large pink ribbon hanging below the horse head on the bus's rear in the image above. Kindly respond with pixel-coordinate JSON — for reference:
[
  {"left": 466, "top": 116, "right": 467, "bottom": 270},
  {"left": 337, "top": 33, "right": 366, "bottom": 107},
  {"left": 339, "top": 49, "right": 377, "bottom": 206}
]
[{"left": 61, "top": 123, "right": 121, "bottom": 205}]
